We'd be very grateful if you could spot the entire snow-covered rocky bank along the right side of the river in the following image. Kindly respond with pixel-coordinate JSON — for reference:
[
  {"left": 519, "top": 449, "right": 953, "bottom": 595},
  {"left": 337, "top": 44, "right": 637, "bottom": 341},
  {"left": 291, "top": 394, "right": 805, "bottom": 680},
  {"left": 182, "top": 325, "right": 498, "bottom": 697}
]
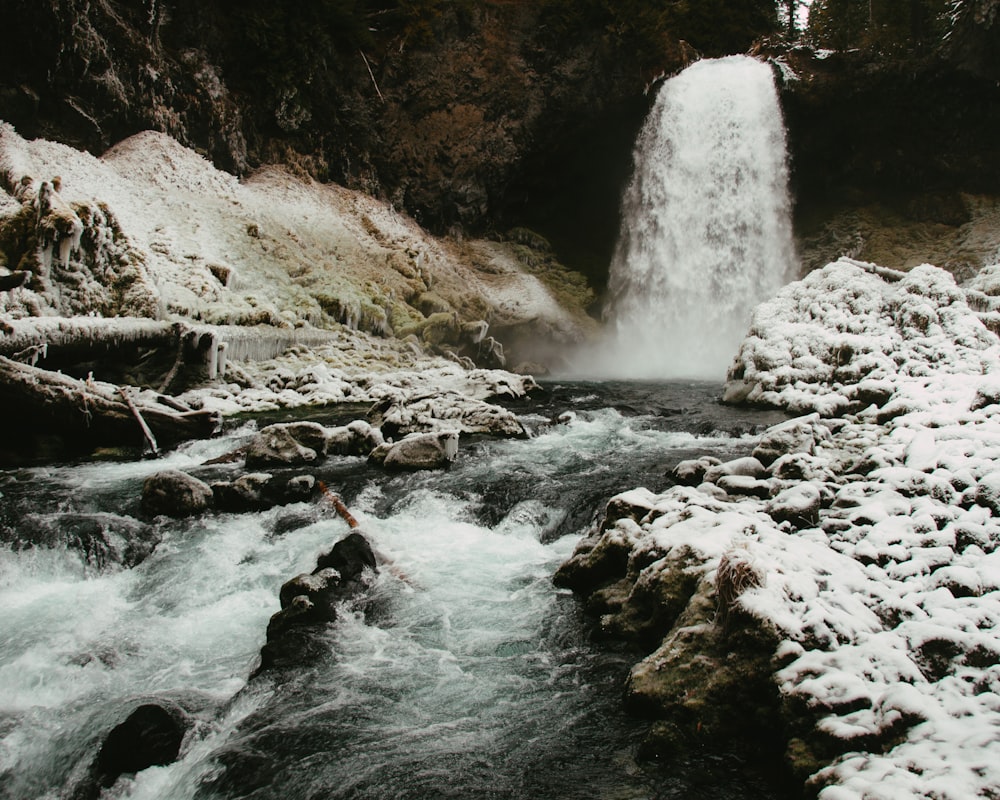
[{"left": 564, "top": 261, "right": 1000, "bottom": 800}]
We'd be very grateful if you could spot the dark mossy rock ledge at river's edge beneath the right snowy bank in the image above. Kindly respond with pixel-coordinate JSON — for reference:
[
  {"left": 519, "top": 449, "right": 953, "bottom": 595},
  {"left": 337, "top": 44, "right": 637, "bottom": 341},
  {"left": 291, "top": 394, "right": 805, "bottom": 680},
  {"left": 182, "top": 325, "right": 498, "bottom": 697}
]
[{"left": 554, "top": 489, "right": 796, "bottom": 783}]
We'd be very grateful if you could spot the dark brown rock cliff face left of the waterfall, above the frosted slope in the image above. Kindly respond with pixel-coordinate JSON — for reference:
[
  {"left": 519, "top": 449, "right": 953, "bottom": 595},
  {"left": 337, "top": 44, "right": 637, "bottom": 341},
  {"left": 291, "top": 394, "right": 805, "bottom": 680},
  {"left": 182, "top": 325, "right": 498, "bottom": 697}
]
[{"left": 0, "top": 0, "right": 693, "bottom": 284}]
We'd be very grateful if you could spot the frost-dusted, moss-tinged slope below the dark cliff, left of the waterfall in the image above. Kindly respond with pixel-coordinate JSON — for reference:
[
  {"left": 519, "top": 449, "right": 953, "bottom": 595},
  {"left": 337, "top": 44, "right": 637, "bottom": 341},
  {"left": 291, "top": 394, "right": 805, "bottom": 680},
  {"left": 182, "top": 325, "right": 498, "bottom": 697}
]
[{"left": 0, "top": 123, "right": 592, "bottom": 368}]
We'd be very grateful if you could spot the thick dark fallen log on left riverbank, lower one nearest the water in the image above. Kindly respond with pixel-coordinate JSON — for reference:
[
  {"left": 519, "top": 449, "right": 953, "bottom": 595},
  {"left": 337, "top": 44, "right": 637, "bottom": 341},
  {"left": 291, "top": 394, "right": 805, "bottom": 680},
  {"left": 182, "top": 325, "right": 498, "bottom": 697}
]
[{"left": 0, "top": 356, "right": 222, "bottom": 454}]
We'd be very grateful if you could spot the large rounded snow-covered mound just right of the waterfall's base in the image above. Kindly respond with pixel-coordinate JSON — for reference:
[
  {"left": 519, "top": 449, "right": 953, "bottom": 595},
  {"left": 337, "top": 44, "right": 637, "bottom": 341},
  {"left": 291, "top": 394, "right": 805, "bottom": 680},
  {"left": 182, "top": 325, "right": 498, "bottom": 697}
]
[{"left": 726, "top": 259, "right": 998, "bottom": 415}]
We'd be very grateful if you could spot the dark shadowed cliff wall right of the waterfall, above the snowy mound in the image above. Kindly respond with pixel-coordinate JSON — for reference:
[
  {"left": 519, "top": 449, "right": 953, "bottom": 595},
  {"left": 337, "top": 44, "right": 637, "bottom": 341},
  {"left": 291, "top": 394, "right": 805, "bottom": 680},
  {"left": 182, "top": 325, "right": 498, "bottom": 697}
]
[{"left": 777, "top": 46, "right": 1000, "bottom": 280}]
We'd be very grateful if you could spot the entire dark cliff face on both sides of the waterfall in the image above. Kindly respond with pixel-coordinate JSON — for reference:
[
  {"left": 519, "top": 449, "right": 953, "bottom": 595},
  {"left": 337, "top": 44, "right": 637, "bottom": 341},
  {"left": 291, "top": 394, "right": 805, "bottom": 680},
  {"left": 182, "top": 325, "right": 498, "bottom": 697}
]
[{"left": 0, "top": 0, "right": 1000, "bottom": 289}]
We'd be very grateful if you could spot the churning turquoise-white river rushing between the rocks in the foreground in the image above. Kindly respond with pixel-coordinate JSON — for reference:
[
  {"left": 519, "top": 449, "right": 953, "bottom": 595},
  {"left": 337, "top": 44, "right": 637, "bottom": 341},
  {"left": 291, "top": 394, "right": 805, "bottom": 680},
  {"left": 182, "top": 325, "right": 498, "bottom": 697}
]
[{"left": 0, "top": 382, "right": 796, "bottom": 800}]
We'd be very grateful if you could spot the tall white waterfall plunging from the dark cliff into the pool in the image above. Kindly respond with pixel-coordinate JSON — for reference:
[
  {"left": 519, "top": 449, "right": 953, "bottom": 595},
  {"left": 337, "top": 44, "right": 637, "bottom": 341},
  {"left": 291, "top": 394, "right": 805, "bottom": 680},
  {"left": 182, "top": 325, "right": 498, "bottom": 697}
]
[{"left": 596, "top": 56, "right": 794, "bottom": 379}]
